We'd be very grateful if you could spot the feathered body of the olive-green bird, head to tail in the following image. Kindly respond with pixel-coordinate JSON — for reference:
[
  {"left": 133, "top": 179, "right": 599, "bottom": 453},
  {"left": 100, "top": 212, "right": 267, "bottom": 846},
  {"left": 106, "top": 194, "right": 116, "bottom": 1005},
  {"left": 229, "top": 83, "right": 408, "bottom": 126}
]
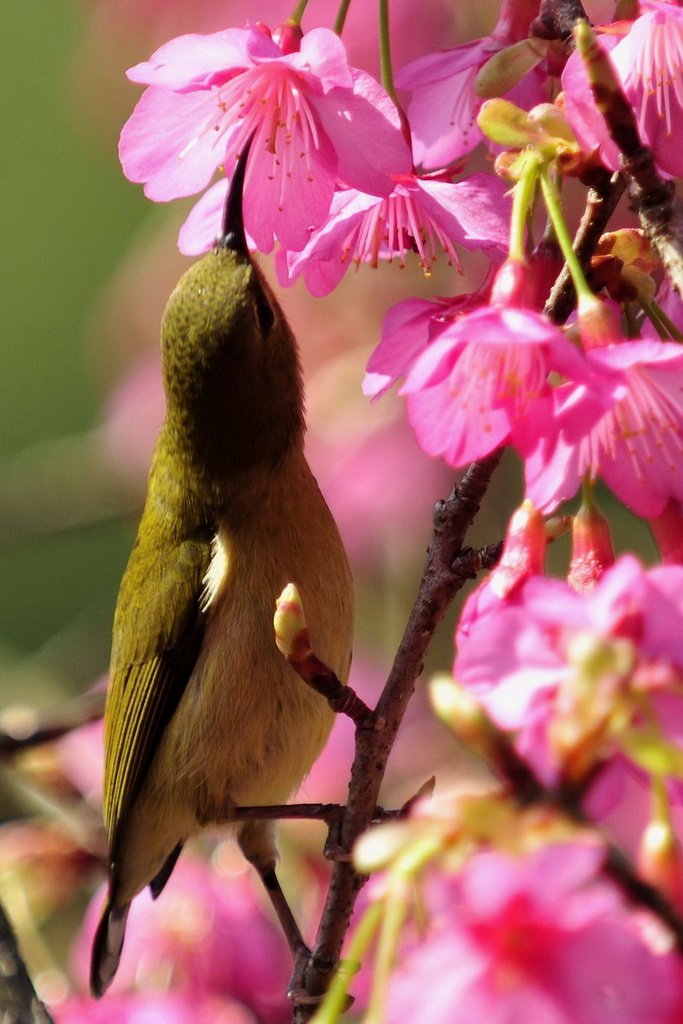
[{"left": 91, "top": 161, "right": 352, "bottom": 994}]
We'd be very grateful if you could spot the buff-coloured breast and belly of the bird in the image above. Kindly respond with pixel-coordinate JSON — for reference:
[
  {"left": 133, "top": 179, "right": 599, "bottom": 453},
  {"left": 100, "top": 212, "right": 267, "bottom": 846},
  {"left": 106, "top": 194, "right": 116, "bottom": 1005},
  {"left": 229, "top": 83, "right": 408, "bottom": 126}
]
[{"left": 165, "top": 491, "right": 350, "bottom": 820}]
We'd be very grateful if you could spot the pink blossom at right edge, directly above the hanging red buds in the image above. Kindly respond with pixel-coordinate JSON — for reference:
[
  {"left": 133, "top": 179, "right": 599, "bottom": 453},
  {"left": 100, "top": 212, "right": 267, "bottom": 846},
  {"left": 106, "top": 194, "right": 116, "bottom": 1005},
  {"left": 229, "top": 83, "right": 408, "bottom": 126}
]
[{"left": 526, "top": 339, "right": 683, "bottom": 518}]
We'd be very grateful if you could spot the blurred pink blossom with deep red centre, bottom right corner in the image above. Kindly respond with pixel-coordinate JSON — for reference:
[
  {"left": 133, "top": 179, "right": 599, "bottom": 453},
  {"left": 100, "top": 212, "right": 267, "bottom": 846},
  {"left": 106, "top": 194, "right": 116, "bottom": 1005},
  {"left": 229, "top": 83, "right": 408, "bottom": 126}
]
[{"left": 388, "top": 843, "right": 681, "bottom": 1024}]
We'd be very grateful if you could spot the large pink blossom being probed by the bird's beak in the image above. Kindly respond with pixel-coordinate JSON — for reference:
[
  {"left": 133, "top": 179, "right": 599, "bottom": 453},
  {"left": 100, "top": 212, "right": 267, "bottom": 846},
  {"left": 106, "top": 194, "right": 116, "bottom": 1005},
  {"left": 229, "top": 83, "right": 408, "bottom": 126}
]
[{"left": 119, "top": 26, "right": 411, "bottom": 252}]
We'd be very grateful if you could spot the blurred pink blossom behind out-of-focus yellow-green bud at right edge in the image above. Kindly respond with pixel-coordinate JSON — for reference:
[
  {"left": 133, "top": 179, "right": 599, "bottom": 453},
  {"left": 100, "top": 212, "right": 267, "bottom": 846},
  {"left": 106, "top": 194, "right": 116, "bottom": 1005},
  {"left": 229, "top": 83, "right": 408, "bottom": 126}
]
[{"left": 454, "top": 556, "right": 683, "bottom": 784}]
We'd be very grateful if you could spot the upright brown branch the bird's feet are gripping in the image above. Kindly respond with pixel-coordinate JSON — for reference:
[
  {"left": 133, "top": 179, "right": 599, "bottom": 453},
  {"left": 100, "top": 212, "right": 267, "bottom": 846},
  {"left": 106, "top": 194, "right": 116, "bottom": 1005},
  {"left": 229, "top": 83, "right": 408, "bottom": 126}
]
[{"left": 293, "top": 453, "right": 500, "bottom": 1024}]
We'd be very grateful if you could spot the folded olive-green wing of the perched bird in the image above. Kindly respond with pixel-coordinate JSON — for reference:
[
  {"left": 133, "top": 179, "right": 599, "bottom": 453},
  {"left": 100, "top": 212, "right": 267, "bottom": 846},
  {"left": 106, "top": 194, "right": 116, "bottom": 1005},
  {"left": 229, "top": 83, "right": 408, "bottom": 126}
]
[{"left": 104, "top": 538, "right": 211, "bottom": 859}]
